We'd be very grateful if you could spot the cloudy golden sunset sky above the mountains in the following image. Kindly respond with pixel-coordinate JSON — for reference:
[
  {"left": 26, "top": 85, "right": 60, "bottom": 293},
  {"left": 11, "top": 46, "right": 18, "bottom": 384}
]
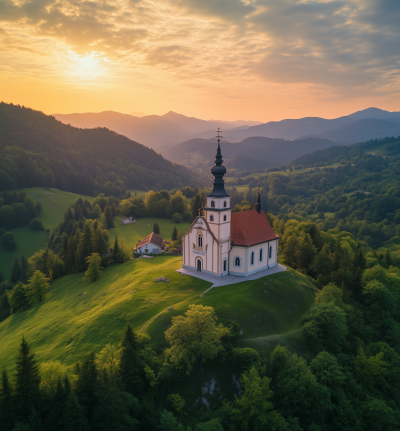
[{"left": 0, "top": 0, "right": 400, "bottom": 121}]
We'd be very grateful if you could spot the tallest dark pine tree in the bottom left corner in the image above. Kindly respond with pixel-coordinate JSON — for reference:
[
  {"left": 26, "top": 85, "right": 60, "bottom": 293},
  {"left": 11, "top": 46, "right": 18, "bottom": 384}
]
[{"left": 15, "top": 337, "right": 40, "bottom": 421}]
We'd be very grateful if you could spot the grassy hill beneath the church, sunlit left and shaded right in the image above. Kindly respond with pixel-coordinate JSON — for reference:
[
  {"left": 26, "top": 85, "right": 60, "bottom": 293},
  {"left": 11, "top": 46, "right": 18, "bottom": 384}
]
[{"left": 0, "top": 256, "right": 315, "bottom": 371}]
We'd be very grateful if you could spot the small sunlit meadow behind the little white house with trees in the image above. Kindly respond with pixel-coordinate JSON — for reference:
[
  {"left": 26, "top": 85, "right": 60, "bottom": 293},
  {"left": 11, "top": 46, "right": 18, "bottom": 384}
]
[{"left": 109, "top": 217, "right": 191, "bottom": 249}]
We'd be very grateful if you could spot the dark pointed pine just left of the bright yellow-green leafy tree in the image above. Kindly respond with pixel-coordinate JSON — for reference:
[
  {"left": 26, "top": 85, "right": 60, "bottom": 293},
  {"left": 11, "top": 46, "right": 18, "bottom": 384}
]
[{"left": 120, "top": 323, "right": 143, "bottom": 395}]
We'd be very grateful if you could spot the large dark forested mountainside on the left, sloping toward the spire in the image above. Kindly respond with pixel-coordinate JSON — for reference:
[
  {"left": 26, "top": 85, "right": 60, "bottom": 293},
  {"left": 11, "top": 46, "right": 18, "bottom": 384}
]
[{"left": 0, "top": 103, "right": 196, "bottom": 196}]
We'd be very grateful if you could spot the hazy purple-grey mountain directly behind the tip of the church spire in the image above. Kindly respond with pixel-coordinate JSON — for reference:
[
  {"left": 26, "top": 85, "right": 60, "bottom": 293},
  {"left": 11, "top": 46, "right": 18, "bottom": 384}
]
[{"left": 163, "top": 137, "right": 340, "bottom": 171}]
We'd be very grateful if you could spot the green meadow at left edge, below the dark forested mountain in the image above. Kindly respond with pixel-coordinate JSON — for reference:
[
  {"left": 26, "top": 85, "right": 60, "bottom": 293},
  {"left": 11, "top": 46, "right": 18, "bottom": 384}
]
[{"left": 0, "top": 187, "right": 92, "bottom": 279}]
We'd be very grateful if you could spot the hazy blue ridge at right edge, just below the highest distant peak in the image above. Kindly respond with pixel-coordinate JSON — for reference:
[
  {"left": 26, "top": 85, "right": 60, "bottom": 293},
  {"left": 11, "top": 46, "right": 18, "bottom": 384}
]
[{"left": 308, "top": 118, "right": 400, "bottom": 144}]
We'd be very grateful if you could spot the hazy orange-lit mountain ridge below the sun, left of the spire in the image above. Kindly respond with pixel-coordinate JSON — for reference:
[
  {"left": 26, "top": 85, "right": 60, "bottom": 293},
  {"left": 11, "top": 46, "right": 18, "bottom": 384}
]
[{"left": 54, "top": 111, "right": 260, "bottom": 149}]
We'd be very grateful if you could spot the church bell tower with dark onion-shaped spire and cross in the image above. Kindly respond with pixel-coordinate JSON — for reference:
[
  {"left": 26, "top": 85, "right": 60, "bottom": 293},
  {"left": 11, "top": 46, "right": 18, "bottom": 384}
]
[{"left": 204, "top": 127, "right": 231, "bottom": 241}]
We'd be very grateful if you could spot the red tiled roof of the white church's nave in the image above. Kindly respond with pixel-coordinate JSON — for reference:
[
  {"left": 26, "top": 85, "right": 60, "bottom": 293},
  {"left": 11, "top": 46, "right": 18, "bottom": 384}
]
[{"left": 231, "top": 210, "right": 279, "bottom": 247}]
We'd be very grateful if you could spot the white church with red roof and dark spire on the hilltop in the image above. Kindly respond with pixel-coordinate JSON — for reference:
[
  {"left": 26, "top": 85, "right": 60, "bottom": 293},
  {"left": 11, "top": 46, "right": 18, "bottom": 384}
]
[{"left": 182, "top": 133, "right": 278, "bottom": 277}]
